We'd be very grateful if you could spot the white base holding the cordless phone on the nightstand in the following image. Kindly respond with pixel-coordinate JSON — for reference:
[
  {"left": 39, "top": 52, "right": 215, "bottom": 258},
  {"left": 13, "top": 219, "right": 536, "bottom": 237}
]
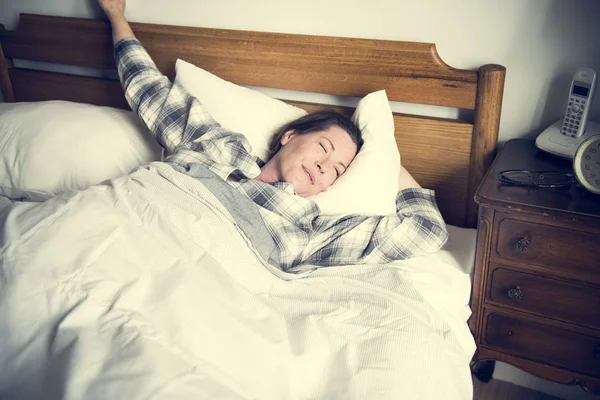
[{"left": 535, "top": 119, "right": 600, "bottom": 160}]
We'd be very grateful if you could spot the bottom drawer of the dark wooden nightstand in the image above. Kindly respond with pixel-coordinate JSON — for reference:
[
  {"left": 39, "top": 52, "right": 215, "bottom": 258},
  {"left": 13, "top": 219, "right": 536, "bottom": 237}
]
[{"left": 485, "top": 313, "right": 600, "bottom": 377}]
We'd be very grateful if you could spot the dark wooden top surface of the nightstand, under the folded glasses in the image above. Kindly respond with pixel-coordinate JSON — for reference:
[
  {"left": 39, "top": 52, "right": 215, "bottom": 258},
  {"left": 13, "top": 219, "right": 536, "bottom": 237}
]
[{"left": 475, "top": 139, "right": 600, "bottom": 219}]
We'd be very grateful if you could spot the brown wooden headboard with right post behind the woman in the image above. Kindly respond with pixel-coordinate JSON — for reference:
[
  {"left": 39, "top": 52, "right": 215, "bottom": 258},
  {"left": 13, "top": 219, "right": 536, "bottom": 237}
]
[{"left": 0, "top": 14, "right": 506, "bottom": 227}]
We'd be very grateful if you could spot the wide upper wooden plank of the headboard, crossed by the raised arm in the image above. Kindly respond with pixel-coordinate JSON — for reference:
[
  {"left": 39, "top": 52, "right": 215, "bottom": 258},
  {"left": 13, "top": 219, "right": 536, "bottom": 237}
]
[{"left": 2, "top": 14, "right": 478, "bottom": 109}]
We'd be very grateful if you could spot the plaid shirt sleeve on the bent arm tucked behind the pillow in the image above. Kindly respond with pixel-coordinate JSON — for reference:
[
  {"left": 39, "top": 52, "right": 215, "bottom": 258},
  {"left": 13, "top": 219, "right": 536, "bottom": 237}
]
[{"left": 301, "top": 188, "right": 448, "bottom": 266}]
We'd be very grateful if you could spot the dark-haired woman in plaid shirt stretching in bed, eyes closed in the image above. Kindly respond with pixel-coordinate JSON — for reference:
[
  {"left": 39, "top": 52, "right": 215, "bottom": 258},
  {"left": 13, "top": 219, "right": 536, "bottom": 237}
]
[{"left": 99, "top": 0, "right": 448, "bottom": 271}]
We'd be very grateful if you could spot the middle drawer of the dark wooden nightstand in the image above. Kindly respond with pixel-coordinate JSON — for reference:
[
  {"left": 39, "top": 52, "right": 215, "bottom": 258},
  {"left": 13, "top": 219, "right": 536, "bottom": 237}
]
[{"left": 487, "top": 266, "right": 600, "bottom": 328}]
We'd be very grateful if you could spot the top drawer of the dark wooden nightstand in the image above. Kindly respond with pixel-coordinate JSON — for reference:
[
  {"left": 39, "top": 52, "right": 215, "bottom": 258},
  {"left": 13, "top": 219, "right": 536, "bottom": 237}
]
[{"left": 495, "top": 214, "right": 600, "bottom": 277}]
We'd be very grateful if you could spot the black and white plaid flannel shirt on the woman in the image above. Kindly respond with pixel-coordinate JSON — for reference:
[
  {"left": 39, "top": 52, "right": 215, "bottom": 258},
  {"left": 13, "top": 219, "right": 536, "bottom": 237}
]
[{"left": 115, "top": 38, "right": 448, "bottom": 271}]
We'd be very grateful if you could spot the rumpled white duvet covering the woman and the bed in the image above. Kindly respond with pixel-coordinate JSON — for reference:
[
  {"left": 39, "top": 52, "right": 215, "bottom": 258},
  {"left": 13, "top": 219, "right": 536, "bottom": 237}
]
[{"left": 0, "top": 163, "right": 475, "bottom": 400}]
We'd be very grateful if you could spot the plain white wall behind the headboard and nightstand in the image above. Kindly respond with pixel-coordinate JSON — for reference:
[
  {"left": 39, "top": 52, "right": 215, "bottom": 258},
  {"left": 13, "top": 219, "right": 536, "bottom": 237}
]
[{"left": 0, "top": 0, "right": 600, "bottom": 398}]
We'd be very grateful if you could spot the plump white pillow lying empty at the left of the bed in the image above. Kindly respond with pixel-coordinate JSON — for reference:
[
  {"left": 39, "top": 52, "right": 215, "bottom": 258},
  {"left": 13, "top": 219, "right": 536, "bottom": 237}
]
[{"left": 0, "top": 101, "right": 161, "bottom": 198}]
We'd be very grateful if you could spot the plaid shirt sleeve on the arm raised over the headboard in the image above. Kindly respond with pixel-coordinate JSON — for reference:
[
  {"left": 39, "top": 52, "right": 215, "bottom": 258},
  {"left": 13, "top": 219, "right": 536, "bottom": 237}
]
[{"left": 115, "top": 38, "right": 254, "bottom": 171}]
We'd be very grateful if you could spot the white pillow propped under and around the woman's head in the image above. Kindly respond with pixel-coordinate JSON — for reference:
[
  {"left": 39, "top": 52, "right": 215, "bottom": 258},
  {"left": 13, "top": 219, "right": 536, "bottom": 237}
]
[{"left": 175, "top": 60, "right": 400, "bottom": 215}]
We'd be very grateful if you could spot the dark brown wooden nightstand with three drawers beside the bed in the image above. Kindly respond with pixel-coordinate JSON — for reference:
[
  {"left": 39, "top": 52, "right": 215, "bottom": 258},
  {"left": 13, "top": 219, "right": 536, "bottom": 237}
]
[{"left": 469, "top": 139, "right": 600, "bottom": 394}]
